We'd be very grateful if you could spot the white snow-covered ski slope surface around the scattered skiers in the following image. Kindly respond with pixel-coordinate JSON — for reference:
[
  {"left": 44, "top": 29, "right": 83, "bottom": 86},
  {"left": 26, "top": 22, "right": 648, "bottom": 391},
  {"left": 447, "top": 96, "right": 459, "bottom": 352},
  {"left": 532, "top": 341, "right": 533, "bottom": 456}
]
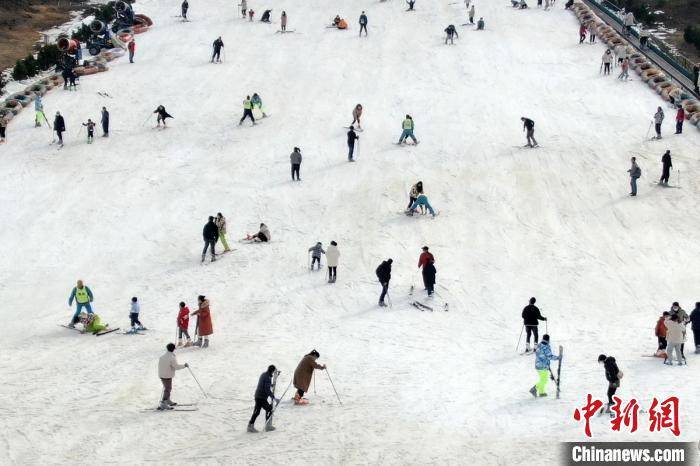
[{"left": 0, "top": 0, "right": 700, "bottom": 465}]
